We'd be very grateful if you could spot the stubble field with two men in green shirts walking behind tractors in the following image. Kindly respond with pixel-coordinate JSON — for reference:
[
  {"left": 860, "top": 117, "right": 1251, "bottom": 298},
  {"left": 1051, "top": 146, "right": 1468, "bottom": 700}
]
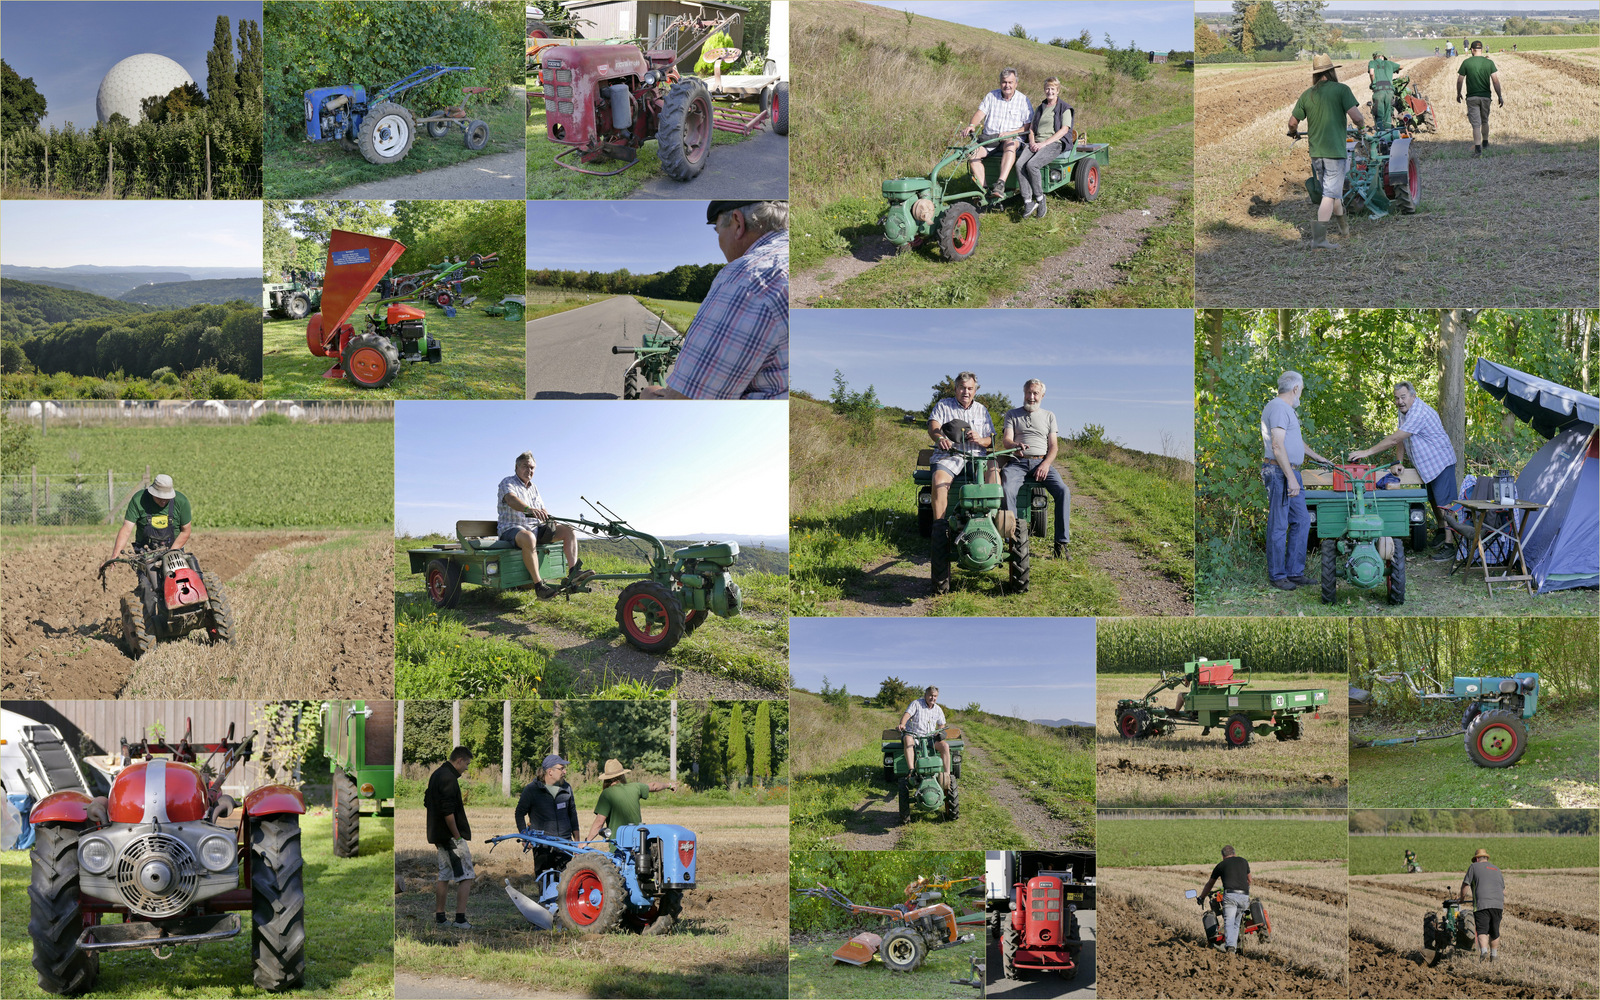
[{"left": 1195, "top": 53, "right": 1600, "bottom": 307}]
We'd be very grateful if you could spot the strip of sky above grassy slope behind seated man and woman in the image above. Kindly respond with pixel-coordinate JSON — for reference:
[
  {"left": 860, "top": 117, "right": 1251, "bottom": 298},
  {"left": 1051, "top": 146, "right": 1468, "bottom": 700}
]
[{"left": 874, "top": 0, "right": 1195, "bottom": 51}]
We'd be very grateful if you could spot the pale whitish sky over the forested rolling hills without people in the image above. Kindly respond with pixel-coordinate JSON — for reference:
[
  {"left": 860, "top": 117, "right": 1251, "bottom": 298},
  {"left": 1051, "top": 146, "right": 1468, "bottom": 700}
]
[{"left": 0, "top": 201, "right": 261, "bottom": 269}]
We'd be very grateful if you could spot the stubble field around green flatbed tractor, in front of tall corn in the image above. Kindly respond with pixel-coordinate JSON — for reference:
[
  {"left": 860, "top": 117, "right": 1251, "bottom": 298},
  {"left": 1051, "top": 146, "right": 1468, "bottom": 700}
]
[{"left": 1094, "top": 674, "right": 1349, "bottom": 808}]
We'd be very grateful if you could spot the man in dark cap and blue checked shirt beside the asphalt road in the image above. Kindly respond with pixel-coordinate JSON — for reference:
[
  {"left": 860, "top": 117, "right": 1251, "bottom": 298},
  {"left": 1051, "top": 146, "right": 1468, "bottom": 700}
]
[{"left": 640, "top": 202, "right": 789, "bottom": 400}]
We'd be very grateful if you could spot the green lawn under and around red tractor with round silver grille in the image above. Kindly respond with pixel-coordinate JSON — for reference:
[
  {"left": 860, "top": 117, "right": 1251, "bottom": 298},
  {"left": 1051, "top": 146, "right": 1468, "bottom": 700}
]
[{"left": 0, "top": 808, "right": 395, "bottom": 998}]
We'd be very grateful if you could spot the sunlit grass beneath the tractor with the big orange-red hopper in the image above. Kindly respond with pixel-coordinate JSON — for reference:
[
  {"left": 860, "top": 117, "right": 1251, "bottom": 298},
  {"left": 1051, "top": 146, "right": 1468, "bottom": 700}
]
[{"left": 261, "top": 294, "right": 528, "bottom": 400}]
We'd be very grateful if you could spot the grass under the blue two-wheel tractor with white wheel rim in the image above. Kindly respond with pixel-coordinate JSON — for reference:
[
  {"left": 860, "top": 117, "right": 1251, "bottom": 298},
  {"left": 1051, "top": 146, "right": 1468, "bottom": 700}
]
[{"left": 262, "top": 98, "right": 525, "bottom": 198}]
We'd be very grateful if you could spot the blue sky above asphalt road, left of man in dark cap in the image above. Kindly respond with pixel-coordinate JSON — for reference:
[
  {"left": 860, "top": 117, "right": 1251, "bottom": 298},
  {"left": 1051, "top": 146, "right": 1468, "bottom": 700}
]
[{"left": 528, "top": 202, "right": 726, "bottom": 274}]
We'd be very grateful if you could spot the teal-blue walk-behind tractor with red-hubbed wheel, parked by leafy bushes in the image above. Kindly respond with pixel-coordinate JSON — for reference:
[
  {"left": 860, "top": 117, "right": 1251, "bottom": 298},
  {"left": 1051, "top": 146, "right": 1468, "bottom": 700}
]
[{"left": 1350, "top": 670, "right": 1539, "bottom": 768}]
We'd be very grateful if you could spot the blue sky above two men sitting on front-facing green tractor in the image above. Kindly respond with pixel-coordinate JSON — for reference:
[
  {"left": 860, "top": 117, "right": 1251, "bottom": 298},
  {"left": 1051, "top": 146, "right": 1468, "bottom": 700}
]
[{"left": 789, "top": 309, "right": 1195, "bottom": 459}]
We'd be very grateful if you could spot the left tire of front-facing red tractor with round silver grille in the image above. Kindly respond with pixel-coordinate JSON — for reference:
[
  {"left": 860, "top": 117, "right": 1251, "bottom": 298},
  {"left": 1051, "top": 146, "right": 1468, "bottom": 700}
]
[{"left": 27, "top": 822, "right": 99, "bottom": 995}]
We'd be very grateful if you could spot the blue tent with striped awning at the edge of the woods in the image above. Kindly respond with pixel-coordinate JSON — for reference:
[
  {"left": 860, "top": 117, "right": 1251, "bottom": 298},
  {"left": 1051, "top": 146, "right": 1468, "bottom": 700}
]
[{"left": 1472, "top": 358, "right": 1600, "bottom": 594}]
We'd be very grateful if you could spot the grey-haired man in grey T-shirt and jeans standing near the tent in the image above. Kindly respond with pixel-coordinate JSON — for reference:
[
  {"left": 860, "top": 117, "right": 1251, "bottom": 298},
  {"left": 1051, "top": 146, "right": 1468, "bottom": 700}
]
[{"left": 1261, "top": 371, "right": 1331, "bottom": 590}]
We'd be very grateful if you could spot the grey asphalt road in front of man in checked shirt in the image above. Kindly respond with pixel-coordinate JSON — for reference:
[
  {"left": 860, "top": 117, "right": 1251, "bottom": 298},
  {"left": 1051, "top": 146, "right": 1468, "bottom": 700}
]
[{"left": 528, "top": 294, "right": 670, "bottom": 400}]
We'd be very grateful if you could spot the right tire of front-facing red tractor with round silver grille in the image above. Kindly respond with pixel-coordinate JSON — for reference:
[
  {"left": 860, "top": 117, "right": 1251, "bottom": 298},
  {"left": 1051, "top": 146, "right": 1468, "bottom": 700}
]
[{"left": 246, "top": 813, "right": 306, "bottom": 990}]
